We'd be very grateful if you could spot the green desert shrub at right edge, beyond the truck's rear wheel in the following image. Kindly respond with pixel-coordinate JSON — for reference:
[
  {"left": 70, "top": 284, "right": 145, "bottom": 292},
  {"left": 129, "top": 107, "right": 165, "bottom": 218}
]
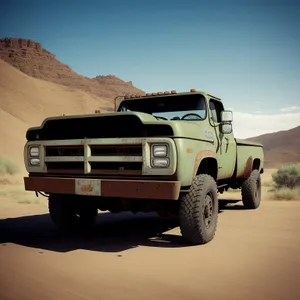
[{"left": 272, "top": 164, "right": 300, "bottom": 189}]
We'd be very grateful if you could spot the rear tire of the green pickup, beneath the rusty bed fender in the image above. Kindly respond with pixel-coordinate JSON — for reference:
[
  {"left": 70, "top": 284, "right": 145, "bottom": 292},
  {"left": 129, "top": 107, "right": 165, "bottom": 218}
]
[{"left": 241, "top": 170, "right": 261, "bottom": 209}]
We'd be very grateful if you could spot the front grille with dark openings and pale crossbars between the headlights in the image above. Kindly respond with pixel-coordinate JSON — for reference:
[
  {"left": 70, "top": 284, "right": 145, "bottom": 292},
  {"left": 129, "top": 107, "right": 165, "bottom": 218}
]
[{"left": 45, "top": 144, "right": 143, "bottom": 175}]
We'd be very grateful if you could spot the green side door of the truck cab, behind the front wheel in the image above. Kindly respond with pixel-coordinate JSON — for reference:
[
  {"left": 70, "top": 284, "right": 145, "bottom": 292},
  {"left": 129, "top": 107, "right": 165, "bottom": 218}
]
[{"left": 209, "top": 99, "right": 237, "bottom": 180}]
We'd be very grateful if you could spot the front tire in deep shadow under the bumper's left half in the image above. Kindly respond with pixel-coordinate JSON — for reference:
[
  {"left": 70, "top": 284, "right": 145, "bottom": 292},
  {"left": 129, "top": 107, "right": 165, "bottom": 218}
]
[{"left": 48, "top": 194, "right": 98, "bottom": 232}]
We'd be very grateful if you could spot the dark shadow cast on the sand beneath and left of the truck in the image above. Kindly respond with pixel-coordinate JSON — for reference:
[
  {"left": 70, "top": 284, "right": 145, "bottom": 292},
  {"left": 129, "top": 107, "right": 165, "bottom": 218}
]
[{"left": 0, "top": 200, "right": 244, "bottom": 252}]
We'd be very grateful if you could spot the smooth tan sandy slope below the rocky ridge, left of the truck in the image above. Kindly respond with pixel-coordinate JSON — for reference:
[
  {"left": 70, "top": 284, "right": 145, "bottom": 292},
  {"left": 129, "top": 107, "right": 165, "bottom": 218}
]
[{"left": 0, "top": 60, "right": 111, "bottom": 164}]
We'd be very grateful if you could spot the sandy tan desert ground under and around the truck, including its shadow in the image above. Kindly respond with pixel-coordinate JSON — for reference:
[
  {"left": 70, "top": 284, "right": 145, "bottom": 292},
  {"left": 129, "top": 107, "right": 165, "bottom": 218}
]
[{"left": 0, "top": 170, "right": 300, "bottom": 300}]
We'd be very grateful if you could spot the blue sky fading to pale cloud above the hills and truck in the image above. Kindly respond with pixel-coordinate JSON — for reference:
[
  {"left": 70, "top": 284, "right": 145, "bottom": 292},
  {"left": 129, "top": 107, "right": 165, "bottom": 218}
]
[{"left": 0, "top": 0, "right": 300, "bottom": 138}]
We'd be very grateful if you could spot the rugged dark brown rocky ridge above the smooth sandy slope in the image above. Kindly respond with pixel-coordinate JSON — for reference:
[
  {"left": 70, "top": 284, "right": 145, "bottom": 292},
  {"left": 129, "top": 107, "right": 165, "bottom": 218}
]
[{"left": 0, "top": 38, "right": 145, "bottom": 102}]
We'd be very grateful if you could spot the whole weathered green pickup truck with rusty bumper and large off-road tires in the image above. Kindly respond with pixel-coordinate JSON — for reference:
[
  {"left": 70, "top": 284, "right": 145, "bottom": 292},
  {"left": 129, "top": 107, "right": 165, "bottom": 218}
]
[{"left": 24, "top": 89, "right": 264, "bottom": 244}]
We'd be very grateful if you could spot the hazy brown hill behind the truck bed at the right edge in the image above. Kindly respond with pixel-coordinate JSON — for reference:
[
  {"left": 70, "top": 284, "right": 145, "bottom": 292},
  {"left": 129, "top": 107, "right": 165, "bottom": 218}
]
[{"left": 247, "top": 126, "right": 300, "bottom": 168}]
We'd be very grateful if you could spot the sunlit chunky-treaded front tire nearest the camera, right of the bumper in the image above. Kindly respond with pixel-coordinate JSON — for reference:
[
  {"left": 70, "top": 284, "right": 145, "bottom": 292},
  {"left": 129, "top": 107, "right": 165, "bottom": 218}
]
[{"left": 179, "top": 174, "right": 219, "bottom": 245}]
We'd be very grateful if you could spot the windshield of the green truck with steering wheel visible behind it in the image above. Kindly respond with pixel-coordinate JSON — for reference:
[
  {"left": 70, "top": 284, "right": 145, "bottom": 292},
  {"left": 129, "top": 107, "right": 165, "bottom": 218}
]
[{"left": 118, "top": 94, "right": 206, "bottom": 120}]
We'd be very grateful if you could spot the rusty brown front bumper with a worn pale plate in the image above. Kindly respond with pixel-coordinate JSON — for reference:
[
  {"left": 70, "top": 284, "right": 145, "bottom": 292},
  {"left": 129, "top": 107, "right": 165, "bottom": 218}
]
[{"left": 24, "top": 177, "right": 180, "bottom": 200}]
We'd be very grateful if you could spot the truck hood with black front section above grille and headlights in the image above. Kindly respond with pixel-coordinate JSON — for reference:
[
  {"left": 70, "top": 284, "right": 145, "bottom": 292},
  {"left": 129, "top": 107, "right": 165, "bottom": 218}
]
[{"left": 26, "top": 112, "right": 211, "bottom": 141}]
